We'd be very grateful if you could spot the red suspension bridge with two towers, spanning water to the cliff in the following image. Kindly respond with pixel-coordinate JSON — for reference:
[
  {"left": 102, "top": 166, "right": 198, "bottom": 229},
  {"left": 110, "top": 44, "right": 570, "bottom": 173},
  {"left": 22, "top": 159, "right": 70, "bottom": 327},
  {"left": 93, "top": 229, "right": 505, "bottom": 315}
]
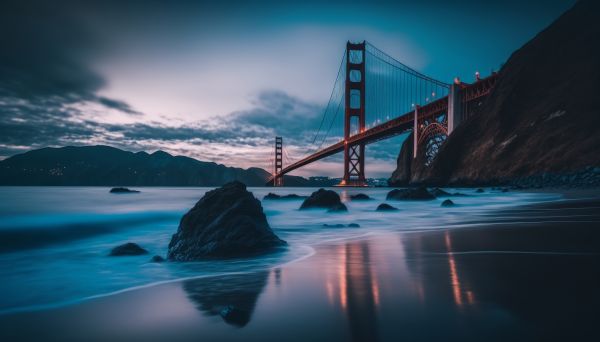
[{"left": 268, "top": 41, "right": 498, "bottom": 186}]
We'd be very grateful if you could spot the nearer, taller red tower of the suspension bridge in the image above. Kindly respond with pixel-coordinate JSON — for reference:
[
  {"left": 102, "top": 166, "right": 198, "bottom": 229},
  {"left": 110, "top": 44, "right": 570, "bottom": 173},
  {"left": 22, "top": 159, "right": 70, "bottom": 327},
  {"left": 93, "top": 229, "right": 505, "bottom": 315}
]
[{"left": 340, "top": 41, "right": 366, "bottom": 186}]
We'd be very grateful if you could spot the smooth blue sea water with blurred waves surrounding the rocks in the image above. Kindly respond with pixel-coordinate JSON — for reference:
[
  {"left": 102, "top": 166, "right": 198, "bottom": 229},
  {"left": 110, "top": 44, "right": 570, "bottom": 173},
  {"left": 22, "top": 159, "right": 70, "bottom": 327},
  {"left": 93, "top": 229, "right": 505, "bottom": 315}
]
[{"left": 0, "top": 187, "right": 561, "bottom": 314}]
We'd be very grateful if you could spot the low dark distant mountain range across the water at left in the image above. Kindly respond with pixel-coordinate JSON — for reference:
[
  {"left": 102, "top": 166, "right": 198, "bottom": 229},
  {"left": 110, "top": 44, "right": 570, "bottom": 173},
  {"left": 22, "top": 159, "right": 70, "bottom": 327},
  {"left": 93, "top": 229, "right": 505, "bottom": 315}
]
[{"left": 0, "top": 146, "right": 328, "bottom": 186}]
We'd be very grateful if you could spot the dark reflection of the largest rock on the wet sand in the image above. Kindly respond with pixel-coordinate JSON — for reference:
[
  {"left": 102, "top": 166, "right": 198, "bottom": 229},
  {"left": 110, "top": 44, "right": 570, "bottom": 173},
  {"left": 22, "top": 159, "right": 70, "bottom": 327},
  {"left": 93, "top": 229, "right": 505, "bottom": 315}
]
[{"left": 182, "top": 271, "right": 269, "bottom": 327}]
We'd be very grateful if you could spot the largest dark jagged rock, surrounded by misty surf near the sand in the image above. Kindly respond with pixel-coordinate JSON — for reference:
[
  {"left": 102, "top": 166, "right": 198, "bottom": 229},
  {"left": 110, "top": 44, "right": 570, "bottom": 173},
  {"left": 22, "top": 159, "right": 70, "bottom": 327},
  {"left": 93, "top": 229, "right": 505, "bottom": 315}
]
[{"left": 167, "top": 181, "right": 286, "bottom": 261}]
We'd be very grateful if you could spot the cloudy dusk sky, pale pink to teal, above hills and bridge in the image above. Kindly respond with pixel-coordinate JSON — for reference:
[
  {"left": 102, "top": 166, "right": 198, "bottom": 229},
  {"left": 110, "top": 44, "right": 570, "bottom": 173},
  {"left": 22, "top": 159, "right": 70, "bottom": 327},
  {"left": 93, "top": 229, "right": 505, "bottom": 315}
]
[{"left": 0, "top": 0, "right": 575, "bottom": 177}]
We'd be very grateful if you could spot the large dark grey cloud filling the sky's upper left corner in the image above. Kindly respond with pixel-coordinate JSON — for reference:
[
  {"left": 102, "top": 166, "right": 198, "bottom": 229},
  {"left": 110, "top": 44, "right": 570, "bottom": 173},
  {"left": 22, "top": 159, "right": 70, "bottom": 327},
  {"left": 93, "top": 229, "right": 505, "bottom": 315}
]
[{"left": 0, "top": 1, "right": 139, "bottom": 114}]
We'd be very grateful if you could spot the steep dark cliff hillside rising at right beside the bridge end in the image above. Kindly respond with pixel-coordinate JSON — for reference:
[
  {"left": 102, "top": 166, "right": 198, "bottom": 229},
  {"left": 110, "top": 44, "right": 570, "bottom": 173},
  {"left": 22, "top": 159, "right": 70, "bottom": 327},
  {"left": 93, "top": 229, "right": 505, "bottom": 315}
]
[{"left": 390, "top": 0, "right": 600, "bottom": 187}]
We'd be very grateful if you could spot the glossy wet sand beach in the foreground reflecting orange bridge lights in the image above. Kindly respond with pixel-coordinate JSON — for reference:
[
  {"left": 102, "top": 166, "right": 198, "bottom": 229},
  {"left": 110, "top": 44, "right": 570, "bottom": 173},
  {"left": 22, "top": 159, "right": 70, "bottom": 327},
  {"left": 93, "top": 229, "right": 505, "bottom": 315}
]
[{"left": 0, "top": 196, "right": 600, "bottom": 341}]
